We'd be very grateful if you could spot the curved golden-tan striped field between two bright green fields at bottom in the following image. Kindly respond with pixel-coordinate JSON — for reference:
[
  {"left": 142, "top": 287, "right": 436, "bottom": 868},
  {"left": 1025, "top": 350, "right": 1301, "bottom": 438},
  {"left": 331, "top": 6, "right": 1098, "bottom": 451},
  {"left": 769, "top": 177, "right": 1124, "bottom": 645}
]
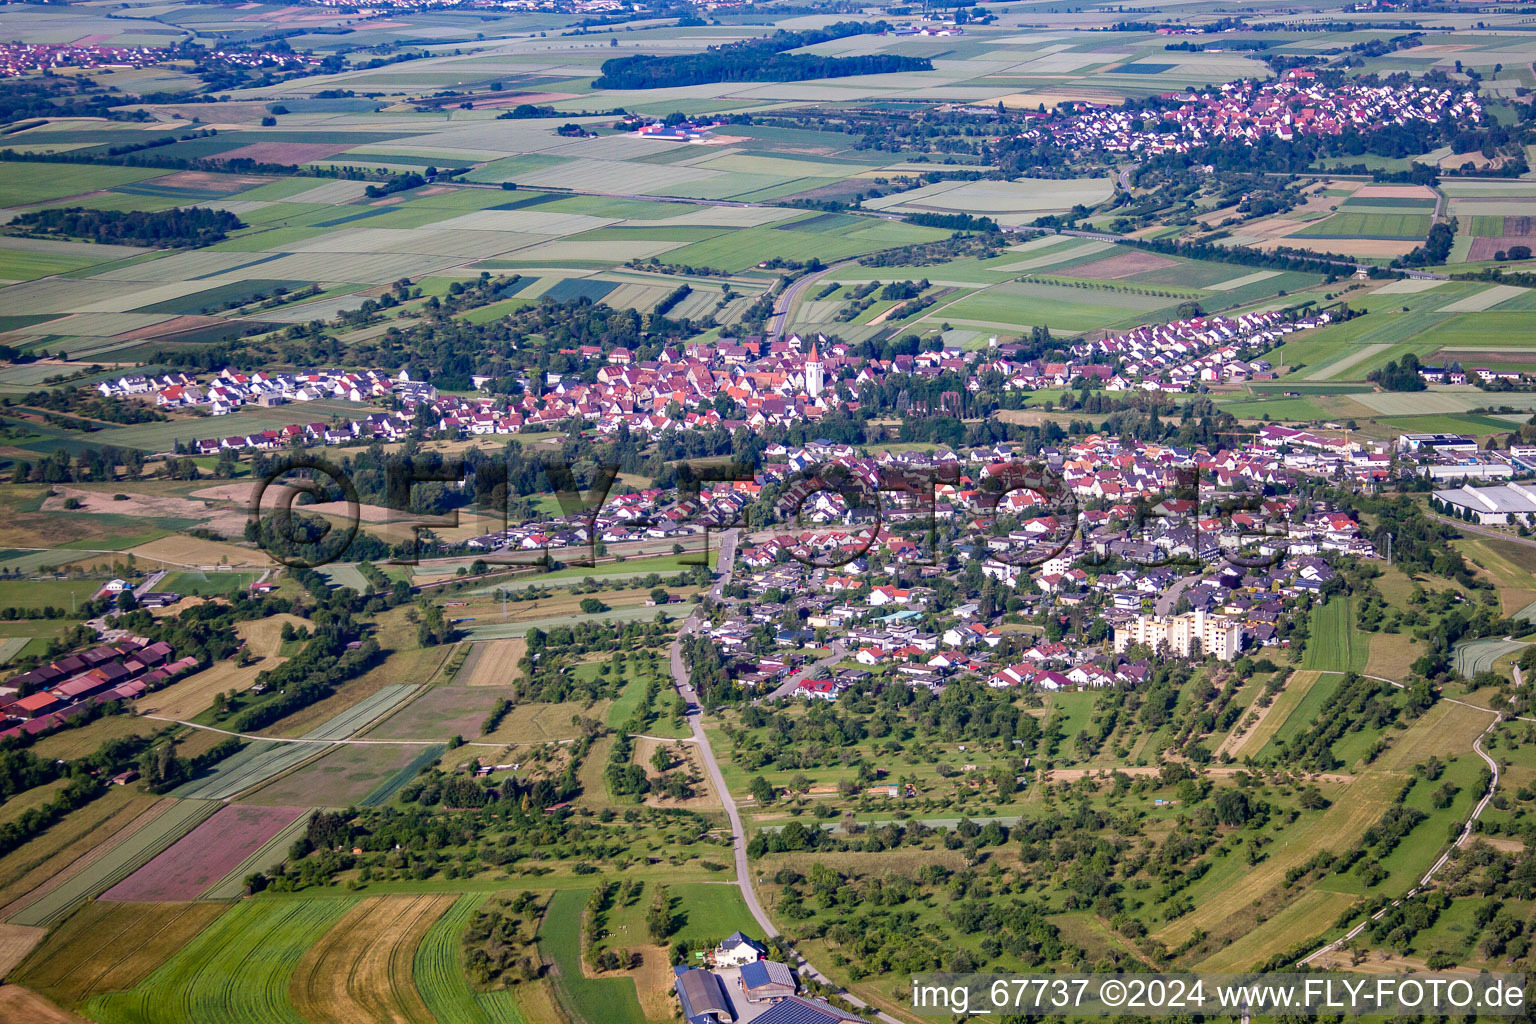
[{"left": 289, "top": 892, "right": 458, "bottom": 1024}]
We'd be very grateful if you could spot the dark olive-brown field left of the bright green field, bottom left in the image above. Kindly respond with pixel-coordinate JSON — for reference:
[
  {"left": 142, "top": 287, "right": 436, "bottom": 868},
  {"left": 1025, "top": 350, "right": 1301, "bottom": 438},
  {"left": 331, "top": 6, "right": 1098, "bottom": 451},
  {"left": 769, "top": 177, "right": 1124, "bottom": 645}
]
[{"left": 17, "top": 900, "right": 229, "bottom": 1006}]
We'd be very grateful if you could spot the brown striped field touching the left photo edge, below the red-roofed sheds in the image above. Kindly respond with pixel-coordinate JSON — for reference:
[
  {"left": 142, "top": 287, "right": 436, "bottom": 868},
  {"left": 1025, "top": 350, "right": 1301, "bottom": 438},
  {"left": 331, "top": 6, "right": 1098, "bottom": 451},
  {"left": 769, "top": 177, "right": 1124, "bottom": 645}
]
[{"left": 0, "top": 786, "right": 160, "bottom": 917}]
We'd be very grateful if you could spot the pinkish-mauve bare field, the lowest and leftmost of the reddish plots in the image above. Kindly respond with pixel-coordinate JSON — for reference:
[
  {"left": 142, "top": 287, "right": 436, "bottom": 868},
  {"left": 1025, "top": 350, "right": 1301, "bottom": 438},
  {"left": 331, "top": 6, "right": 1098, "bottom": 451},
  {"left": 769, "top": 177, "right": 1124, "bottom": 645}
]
[{"left": 101, "top": 804, "right": 304, "bottom": 903}]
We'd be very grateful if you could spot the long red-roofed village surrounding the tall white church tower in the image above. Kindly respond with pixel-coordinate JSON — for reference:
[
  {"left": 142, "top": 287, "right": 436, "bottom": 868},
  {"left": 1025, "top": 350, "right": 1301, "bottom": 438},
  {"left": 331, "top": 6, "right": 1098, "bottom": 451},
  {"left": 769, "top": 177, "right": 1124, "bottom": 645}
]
[{"left": 97, "top": 303, "right": 1332, "bottom": 454}]
